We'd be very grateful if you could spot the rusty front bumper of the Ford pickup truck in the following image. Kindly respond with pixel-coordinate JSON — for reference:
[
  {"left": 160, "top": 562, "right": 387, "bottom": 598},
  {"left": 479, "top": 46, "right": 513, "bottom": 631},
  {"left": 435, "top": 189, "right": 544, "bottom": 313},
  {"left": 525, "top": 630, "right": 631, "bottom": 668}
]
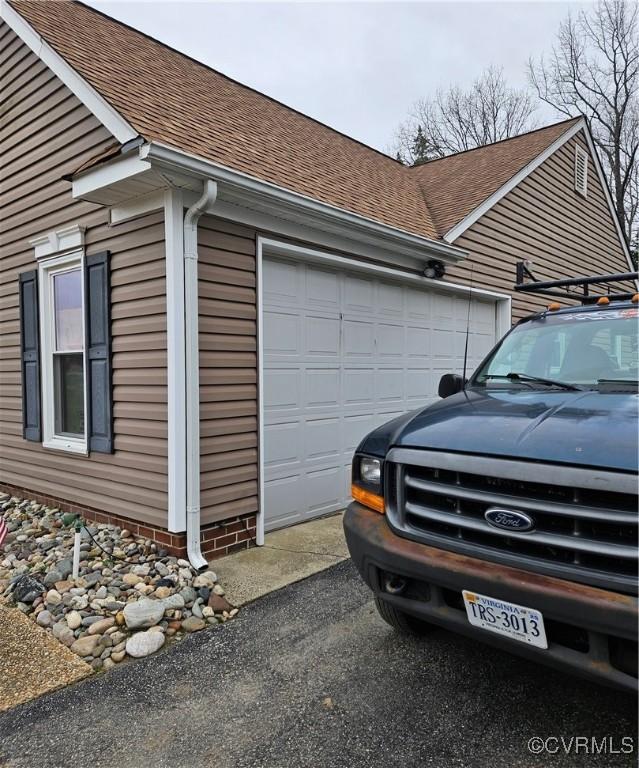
[{"left": 344, "top": 502, "right": 638, "bottom": 691}]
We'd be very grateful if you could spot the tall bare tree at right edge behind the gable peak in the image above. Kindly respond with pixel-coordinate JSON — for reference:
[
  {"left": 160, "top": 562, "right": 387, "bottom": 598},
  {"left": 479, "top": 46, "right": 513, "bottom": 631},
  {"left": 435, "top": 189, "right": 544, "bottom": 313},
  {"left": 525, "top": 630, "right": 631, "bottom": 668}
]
[{"left": 528, "top": 0, "right": 639, "bottom": 242}]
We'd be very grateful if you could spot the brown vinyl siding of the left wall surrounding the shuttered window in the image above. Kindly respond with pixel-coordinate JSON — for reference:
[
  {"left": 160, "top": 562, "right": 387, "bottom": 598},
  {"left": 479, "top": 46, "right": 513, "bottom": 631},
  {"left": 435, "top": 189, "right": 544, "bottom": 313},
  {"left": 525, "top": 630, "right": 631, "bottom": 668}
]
[{"left": 0, "top": 24, "right": 167, "bottom": 527}]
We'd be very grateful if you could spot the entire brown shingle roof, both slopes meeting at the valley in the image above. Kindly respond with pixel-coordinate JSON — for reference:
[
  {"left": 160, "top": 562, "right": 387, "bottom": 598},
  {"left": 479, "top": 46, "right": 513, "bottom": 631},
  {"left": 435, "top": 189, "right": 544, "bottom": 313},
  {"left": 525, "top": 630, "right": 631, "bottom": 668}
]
[{"left": 6, "top": 0, "right": 584, "bottom": 238}]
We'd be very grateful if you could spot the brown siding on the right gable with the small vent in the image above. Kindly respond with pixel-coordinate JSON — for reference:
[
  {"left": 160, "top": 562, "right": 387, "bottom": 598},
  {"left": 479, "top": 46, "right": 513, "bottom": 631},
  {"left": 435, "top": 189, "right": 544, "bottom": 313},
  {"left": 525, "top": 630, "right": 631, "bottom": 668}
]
[{"left": 446, "top": 134, "right": 629, "bottom": 319}]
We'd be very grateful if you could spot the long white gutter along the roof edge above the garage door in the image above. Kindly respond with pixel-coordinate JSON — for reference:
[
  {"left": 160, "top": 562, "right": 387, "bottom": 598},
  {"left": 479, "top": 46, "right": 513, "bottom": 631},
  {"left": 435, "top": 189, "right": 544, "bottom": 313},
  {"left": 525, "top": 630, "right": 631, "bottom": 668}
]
[{"left": 140, "top": 142, "right": 466, "bottom": 264}]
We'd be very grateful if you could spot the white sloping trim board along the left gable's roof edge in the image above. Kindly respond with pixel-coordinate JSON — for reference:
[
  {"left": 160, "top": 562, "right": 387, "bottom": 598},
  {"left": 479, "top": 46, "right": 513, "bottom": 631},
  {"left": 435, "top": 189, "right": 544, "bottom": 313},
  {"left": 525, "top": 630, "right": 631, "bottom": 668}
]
[{"left": 0, "top": 0, "right": 139, "bottom": 144}]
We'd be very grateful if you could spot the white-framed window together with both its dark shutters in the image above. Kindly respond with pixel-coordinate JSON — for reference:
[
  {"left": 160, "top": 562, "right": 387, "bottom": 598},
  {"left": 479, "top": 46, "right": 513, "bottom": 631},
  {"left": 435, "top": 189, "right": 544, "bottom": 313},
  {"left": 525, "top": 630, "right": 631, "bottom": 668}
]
[{"left": 20, "top": 246, "right": 113, "bottom": 454}]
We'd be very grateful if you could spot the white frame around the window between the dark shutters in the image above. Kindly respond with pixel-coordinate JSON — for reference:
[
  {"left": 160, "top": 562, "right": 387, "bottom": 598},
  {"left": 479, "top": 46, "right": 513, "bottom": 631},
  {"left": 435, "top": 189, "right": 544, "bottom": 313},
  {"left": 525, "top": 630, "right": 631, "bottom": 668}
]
[{"left": 38, "top": 250, "right": 88, "bottom": 456}]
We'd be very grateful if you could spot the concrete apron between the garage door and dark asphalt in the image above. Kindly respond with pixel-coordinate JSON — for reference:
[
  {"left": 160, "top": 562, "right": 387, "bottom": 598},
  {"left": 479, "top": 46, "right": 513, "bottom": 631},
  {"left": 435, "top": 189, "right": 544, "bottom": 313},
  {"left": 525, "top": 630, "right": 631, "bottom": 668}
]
[{"left": 211, "top": 513, "right": 349, "bottom": 606}]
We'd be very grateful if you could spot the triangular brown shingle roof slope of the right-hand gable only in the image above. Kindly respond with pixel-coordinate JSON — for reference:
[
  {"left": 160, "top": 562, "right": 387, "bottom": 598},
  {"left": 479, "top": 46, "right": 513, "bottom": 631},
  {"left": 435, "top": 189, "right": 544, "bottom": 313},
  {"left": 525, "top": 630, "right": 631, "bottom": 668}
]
[{"left": 411, "top": 117, "right": 582, "bottom": 236}]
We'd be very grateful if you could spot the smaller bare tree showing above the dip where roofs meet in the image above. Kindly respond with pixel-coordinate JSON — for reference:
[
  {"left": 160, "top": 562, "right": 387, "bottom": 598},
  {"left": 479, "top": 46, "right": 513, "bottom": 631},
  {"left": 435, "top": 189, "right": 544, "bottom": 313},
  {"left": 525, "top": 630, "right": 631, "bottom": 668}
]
[{"left": 395, "top": 67, "right": 535, "bottom": 164}]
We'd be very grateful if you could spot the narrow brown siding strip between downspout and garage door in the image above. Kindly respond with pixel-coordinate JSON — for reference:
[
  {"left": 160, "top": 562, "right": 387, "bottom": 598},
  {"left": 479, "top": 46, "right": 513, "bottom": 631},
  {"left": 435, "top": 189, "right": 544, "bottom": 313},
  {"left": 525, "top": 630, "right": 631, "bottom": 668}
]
[{"left": 198, "top": 216, "right": 258, "bottom": 525}]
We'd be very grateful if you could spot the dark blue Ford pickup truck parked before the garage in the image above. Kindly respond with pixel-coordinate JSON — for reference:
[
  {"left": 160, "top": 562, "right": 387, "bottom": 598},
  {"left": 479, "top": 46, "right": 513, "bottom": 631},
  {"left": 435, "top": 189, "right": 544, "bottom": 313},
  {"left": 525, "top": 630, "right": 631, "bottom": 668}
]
[{"left": 344, "top": 280, "right": 639, "bottom": 691}]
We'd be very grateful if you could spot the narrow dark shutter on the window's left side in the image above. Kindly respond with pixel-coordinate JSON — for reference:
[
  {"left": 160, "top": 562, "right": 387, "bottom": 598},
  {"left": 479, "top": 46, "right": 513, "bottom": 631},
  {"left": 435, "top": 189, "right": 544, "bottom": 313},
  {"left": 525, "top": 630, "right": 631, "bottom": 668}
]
[{"left": 20, "top": 270, "right": 42, "bottom": 442}]
